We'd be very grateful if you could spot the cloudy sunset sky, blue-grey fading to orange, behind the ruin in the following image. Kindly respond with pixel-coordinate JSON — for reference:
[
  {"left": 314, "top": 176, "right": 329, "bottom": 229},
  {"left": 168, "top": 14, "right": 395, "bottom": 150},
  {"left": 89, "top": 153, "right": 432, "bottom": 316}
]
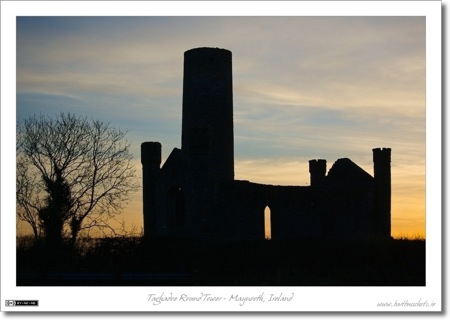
[{"left": 16, "top": 16, "right": 426, "bottom": 237}]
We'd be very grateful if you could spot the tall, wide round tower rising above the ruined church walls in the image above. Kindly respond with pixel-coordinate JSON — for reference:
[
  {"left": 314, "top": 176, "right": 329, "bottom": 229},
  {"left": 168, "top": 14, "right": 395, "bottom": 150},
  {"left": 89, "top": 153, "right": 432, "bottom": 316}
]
[{"left": 181, "top": 48, "right": 234, "bottom": 180}]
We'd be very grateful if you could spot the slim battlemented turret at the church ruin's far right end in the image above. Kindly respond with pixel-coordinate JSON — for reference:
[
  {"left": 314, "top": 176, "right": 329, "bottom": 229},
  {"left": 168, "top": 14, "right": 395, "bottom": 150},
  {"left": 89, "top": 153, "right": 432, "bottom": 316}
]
[{"left": 372, "top": 148, "right": 391, "bottom": 237}]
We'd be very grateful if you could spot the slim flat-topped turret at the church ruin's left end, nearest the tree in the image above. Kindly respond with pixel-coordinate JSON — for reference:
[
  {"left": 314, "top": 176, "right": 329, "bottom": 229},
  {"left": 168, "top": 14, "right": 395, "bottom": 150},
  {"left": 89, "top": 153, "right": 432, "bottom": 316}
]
[{"left": 141, "top": 142, "right": 161, "bottom": 236}]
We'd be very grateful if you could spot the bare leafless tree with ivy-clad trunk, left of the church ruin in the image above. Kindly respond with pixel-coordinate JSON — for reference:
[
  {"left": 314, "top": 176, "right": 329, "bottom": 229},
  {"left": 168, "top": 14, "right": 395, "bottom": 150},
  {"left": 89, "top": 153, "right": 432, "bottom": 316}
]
[{"left": 16, "top": 113, "right": 138, "bottom": 242}]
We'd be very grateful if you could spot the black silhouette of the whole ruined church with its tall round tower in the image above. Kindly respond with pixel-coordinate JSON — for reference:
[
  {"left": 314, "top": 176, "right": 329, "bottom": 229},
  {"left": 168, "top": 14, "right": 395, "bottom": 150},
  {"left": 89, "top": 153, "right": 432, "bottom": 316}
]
[{"left": 141, "top": 48, "right": 391, "bottom": 241}]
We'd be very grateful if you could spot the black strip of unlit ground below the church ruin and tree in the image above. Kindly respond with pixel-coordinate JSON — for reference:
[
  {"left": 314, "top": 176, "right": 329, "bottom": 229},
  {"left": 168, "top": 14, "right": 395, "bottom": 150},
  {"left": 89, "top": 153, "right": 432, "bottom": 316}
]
[{"left": 17, "top": 237, "right": 426, "bottom": 286}]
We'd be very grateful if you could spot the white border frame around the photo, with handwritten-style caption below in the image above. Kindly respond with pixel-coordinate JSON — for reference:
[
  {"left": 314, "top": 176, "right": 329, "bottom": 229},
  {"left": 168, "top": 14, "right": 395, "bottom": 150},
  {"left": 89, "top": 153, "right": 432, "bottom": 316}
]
[{"left": 0, "top": 1, "right": 443, "bottom": 312}]
